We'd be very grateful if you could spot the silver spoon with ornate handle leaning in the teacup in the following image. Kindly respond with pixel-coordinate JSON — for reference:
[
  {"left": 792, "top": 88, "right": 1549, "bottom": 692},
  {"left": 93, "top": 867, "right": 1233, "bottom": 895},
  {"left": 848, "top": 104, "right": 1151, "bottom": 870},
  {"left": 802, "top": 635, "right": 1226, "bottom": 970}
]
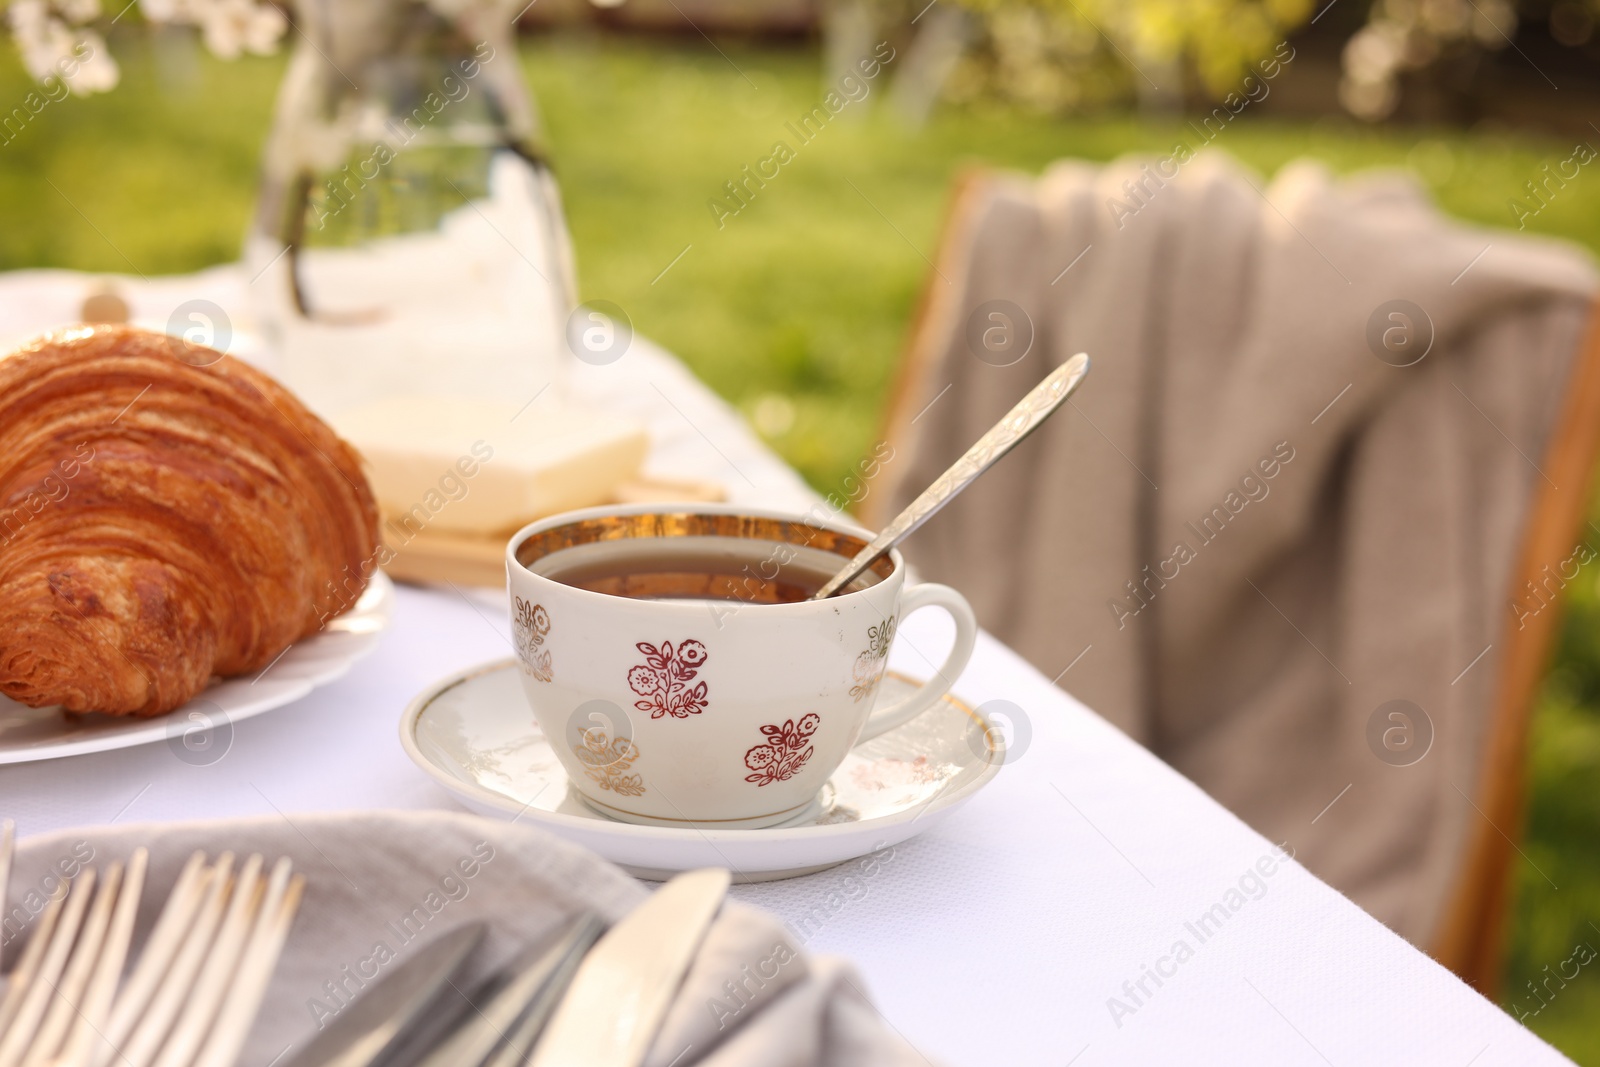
[{"left": 811, "top": 352, "right": 1090, "bottom": 600}]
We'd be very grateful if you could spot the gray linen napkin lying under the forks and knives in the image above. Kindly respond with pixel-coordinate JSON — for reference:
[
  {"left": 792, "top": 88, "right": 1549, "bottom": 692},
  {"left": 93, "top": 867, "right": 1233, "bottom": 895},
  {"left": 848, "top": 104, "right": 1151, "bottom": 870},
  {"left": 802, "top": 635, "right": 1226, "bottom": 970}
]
[{"left": 0, "top": 811, "right": 926, "bottom": 1067}]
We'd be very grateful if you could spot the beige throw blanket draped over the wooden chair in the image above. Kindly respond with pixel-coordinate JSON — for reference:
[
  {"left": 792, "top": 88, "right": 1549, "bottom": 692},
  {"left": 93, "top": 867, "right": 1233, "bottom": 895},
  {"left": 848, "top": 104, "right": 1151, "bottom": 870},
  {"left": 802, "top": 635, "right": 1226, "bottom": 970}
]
[{"left": 875, "top": 154, "right": 1595, "bottom": 945}]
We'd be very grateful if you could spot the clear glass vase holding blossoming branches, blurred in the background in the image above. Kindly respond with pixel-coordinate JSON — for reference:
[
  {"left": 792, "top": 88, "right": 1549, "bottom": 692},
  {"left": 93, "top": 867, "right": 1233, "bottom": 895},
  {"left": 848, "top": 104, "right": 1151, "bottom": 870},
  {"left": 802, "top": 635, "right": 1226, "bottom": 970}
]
[{"left": 246, "top": 0, "right": 574, "bottom": 424}]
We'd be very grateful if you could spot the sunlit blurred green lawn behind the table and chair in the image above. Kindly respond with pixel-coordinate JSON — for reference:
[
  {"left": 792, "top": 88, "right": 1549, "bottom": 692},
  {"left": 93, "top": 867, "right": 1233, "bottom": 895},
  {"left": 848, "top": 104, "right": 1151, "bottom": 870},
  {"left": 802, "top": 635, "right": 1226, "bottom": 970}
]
[{"left": 0, "top": 35, "right": 1600, "bottom": 1065}]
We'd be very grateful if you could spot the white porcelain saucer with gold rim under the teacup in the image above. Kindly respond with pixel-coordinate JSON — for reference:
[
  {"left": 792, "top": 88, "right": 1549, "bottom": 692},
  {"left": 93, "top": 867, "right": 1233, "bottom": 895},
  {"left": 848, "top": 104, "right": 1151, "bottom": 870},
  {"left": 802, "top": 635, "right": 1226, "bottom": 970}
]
[{"left": 400, "top": 659, "right": 1005, "bottom": 881}]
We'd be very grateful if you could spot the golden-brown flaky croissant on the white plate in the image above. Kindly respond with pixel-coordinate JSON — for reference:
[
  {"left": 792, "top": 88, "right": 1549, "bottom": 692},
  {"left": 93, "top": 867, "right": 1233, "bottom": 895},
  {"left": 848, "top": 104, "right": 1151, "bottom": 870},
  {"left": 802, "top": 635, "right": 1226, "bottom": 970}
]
[{"left": 0, "top": 326, "right": 379, "bottom": 715}]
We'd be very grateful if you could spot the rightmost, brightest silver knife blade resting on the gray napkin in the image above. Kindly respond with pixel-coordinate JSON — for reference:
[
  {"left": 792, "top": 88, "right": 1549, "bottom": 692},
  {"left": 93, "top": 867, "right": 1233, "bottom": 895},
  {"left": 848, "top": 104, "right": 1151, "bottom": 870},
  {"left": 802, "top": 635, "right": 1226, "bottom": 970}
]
[{"left": 528, "top": 869, "right": 728, "bottom": 1067}]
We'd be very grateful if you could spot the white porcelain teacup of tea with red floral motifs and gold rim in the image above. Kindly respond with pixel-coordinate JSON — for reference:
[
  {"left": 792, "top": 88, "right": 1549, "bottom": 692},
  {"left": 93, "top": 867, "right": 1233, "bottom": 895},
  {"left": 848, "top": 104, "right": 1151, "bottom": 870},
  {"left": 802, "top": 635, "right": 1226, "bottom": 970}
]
[{"left": 506, "top": 504, "right": 978, "bottom": 829}]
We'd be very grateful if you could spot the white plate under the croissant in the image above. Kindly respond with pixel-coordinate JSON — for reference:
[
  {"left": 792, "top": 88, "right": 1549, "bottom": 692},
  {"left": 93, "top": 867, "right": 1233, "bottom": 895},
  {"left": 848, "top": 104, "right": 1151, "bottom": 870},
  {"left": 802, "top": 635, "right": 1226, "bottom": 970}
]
[{"left": 0, "top": 571, "right": 395, "bottom": 763}]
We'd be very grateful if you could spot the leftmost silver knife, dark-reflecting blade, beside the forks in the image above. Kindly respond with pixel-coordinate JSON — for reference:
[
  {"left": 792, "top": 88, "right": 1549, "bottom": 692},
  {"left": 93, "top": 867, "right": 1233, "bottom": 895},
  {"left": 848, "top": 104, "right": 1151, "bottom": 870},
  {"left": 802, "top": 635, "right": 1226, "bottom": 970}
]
[{"left": 283, "top": 921, "right": 488, "bottom": 1067}]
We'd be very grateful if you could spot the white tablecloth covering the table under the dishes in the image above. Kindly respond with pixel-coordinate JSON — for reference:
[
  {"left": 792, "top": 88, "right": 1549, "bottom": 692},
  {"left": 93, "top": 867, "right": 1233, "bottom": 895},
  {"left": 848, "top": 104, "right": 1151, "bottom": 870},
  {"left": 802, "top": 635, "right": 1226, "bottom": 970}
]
[{"left": 0, "top": 269, "right": 1566, "bottom": 1067}]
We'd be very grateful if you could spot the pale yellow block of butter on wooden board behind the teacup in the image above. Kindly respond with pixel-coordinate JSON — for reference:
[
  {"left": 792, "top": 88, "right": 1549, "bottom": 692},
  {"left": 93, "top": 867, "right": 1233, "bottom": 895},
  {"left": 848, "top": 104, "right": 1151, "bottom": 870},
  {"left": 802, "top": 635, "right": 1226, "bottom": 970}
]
[{"left": 333, "top": 395, "right": 650, "bottom": 539}]
